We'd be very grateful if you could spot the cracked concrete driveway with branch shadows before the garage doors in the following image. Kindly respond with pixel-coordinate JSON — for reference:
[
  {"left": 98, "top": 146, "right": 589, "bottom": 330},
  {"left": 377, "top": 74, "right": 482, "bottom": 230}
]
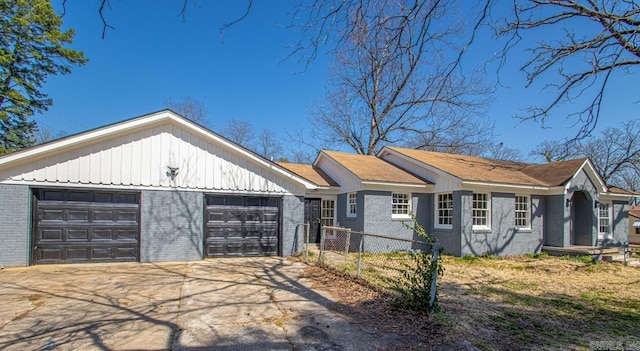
[{"left": 0, "top": 258, "right": 406, "bottom": 350}]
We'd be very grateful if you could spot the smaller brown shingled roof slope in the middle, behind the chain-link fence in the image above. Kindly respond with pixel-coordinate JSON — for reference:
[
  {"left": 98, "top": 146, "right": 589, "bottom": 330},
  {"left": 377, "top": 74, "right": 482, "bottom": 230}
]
[{"left": 322, "top": 151, "right": 432, "bottom": 185}]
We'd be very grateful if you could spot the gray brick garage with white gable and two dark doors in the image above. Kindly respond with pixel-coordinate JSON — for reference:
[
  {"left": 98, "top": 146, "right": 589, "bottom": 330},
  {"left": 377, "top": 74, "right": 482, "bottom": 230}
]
[{"left": 0, "top": 110, "right": 315, "bottom": 266}]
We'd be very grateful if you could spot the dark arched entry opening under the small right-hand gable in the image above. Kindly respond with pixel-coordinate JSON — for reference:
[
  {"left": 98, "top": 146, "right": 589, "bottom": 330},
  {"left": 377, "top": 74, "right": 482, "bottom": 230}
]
[{"left": 571, "top": 191, "right": 595, "bottom": 246}]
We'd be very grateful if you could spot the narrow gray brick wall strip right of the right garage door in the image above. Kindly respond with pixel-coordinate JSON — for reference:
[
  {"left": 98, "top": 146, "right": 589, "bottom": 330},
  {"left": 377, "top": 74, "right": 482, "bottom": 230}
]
[{"left": 281, "top": 196, "right": 304, "bottom": 257}]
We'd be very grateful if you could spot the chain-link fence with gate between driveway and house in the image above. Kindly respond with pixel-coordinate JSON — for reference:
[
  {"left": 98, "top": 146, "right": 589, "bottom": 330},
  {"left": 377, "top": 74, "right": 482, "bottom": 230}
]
[{"left": 304, "top": 227, "right": 439, "bottom": 306}]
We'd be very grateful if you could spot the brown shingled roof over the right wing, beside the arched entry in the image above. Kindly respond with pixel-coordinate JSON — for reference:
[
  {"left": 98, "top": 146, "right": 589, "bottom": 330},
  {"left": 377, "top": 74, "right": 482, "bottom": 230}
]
[{"left": 388, "top": 147, "right": 587, "bottom": 186}]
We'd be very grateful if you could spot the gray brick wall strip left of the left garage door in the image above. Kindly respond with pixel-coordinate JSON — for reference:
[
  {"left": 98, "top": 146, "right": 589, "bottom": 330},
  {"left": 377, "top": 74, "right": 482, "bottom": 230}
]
[{"left": 0, "top": 184, "right": 31, "bottom": 267}]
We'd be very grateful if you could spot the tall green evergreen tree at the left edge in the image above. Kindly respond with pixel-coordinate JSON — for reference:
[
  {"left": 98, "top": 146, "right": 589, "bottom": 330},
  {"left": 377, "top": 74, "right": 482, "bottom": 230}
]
[{"left": 0, "top": 0, "right": 87, "bottom": 154}]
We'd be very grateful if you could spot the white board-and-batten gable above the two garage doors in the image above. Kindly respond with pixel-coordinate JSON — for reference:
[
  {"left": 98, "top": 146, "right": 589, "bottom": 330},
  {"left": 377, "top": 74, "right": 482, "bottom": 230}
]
[{"left": 0, "top": 110, "right": 314, "bottom": 195}]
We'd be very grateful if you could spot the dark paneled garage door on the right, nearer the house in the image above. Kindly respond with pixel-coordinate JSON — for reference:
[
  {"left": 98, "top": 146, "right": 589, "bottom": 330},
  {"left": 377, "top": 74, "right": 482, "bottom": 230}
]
[{"left": 204, "top": 195, "right": 280, "bottom": 257}]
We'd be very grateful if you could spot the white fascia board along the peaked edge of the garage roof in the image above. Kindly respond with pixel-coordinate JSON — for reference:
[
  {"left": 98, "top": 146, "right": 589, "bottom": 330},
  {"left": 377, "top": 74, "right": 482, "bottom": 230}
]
[{"left": 0, "top": 110, "right": 317, "bottom": 189}]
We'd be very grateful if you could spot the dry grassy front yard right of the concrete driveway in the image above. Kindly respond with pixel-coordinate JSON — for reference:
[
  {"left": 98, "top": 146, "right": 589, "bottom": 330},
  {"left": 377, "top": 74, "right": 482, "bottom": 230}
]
[{"left": 305, "top": 256, "right": 640, "bottom": 350}]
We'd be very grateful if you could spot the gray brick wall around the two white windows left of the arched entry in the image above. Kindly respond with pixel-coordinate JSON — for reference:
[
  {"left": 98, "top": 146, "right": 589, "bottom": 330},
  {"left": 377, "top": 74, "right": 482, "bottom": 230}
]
[{"left": 462, "top": 193, "right": 543, "bottom": 256}]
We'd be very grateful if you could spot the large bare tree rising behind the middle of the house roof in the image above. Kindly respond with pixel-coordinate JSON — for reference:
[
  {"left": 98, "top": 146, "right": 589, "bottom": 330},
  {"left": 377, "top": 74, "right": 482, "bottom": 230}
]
[{"left": 310, "top": 0, "right": 493, "bottom": 154}]
